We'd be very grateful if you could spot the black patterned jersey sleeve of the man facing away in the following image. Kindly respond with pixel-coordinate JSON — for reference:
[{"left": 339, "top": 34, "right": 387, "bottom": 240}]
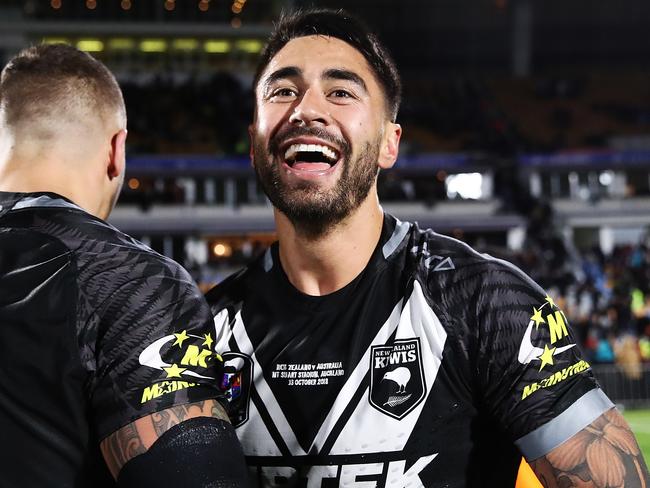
[{"left": 80, "top": 248, "right": 222, "bottom": 438}]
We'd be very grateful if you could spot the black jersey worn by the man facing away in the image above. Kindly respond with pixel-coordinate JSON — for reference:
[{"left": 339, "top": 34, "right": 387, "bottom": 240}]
[{"left": 0, "top": 192, "right": 223, "bottom": 488}]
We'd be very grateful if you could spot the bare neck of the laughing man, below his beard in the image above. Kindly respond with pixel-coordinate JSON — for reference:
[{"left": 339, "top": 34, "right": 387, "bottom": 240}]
[{"left": 275, "top": 191, "right": 383, "bottom": 296}]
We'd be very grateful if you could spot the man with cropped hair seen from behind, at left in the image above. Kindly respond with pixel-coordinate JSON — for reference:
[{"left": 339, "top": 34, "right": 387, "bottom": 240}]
[{"left": 0, "top": 45, "right": 246, "bottom": 488}]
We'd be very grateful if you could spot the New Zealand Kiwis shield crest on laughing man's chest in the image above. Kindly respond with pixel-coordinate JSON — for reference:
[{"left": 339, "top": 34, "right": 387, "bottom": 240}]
[{"left": 369, "top": 338, "right": 426, "bottom": 420}]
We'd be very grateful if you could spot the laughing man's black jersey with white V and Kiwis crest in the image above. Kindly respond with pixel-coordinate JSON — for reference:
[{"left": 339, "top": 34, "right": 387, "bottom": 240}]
[{"left": 207, "top": 216, "right": 612, "bottom": 488}]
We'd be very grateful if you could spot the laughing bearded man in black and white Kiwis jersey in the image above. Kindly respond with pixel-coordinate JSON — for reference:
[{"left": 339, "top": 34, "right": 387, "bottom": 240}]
[{"left": 208, "top": 10, "right": 648, "bottom": 488}]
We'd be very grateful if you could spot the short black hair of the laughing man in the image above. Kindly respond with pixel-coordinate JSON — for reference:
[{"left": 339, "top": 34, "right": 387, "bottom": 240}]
[{"left": 253, "top": 9, "right": 402, "bottom": 121}]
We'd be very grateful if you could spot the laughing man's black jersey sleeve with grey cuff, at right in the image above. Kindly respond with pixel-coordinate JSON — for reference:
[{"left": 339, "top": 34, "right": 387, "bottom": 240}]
[{"left": 476, "top": 260, "right": 612, "bottom": 459}]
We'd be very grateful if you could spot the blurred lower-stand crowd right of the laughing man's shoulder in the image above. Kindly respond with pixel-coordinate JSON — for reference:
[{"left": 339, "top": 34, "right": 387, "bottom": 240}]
[{"left": 507, "top": 224, "right": 650, "bottom": 375}]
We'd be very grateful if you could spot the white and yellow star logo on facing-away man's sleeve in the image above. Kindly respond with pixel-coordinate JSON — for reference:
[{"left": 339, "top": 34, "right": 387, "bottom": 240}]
[{"left": 138, "top": 330, "right": 221, "bottom": 403}]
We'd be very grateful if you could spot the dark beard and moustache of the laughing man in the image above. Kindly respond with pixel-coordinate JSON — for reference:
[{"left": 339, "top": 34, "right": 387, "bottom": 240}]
[{"left": 253, "top": 127, "right": 380, "bottom": 239}]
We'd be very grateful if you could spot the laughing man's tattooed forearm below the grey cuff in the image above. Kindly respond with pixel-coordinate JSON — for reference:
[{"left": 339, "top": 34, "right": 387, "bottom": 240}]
[{"left": 530, "top": 409, "right": 650, "bottom": 488}]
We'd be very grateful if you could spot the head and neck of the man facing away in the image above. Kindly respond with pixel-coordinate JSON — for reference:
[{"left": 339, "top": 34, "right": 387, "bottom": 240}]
[{"left": 0, "top": 44, "right": 126, "bottom": 218}]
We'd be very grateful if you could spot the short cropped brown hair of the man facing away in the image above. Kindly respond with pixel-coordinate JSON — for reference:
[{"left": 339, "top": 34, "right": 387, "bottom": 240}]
[{"left": 0, "top": 44, "right": 126, "bottom": 142}]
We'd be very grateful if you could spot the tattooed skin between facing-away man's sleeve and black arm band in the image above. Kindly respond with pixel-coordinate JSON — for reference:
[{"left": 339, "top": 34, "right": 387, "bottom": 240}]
[{"left": 100, "top": 400, "right": 229, "bottom": 478}]
